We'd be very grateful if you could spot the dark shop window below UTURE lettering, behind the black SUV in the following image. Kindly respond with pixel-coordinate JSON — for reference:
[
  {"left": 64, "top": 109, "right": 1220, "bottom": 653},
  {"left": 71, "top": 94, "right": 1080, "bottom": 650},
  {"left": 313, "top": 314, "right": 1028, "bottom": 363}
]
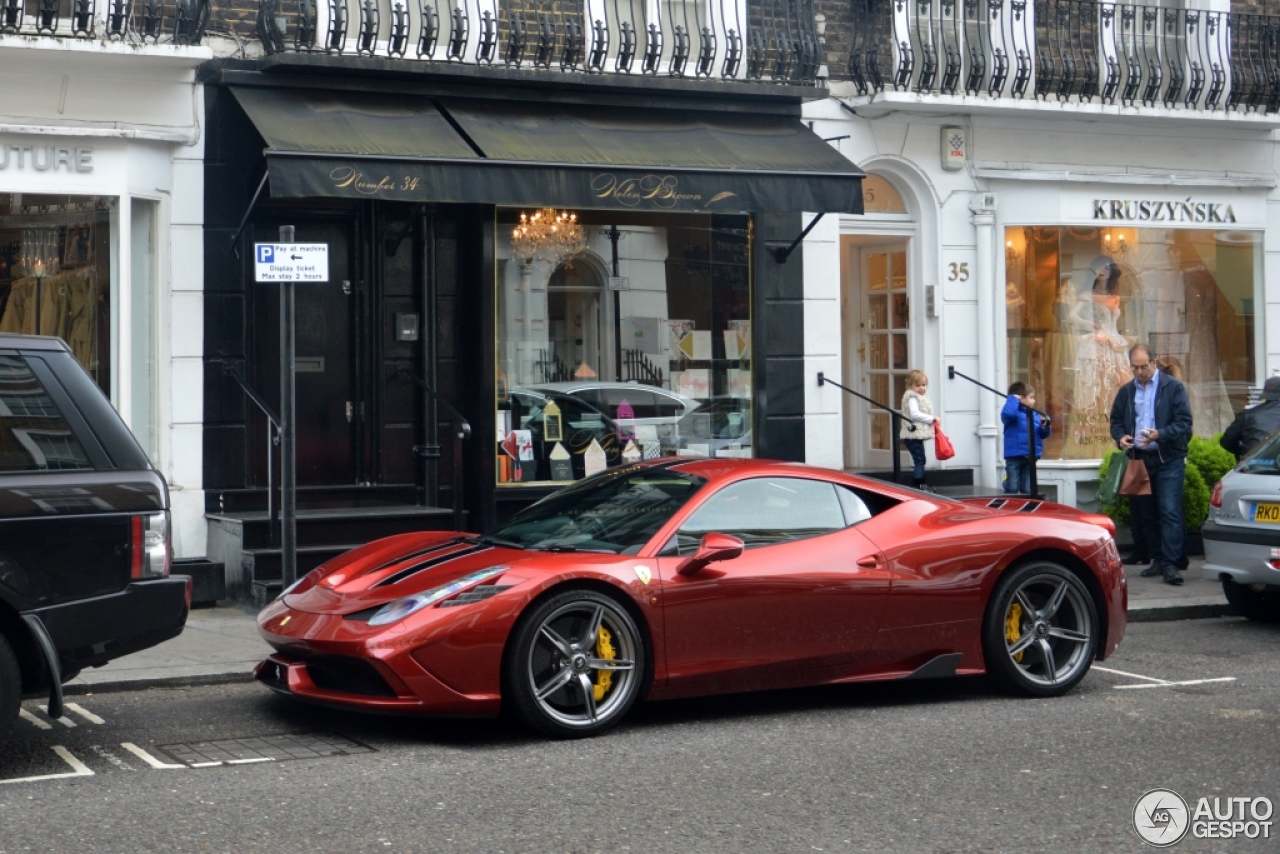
[{"left": 0, "top": 193, "right": 115, "bottom": 393}]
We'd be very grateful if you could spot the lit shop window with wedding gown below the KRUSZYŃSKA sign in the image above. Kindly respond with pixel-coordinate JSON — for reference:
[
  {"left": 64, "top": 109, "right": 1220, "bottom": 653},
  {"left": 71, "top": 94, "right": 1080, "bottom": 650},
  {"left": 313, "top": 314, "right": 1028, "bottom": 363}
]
[{"left": 1005, "top": 227, "right": 1262, "bottom": 460}]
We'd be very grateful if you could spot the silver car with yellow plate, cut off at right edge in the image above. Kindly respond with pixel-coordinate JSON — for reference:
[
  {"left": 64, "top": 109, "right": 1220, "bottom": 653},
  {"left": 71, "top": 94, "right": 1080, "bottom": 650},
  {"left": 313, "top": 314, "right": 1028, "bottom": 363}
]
[{"left": 1201, "top": 433, "right": 1280, "bottom": 622}]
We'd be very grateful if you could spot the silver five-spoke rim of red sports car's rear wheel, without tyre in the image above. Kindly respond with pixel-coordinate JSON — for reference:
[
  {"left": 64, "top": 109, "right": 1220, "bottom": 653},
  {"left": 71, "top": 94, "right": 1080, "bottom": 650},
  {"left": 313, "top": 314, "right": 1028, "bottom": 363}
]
[{"left": 1005, "top": 572, "right": 1094, "bottom": 688}]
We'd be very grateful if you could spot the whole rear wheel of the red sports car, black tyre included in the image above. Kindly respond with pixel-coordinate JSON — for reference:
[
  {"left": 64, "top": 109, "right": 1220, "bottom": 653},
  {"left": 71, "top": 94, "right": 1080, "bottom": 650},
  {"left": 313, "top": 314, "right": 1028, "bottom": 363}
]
[{"left": 982, "top": 561, "right": 1102, "bottom": 697}]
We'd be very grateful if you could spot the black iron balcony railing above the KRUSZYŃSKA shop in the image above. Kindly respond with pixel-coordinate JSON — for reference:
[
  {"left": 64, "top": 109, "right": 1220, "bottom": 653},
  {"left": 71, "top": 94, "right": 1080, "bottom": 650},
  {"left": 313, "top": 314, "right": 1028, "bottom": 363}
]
[{"left": 849, "top": 0, "right": 1280, "bottom": 113}]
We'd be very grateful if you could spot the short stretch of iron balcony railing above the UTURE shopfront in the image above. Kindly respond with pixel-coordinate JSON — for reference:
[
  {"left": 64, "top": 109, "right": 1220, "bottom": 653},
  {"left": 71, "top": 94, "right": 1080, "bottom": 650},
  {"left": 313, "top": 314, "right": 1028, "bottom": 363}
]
[{"left": 0, "top": 0, "right": 210, "bottom": 45}]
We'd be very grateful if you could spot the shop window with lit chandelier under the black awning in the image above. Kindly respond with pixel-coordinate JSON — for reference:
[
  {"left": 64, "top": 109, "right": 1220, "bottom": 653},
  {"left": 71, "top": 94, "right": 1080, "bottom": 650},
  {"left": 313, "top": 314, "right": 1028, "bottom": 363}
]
[{"left": 495, "top": 209, "right": 751, "bottom": 485}]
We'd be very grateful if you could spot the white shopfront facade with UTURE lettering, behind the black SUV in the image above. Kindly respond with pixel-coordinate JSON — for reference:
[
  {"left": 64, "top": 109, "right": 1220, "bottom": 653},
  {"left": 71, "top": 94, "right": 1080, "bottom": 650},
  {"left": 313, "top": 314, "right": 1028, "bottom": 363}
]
[{"left": 0, "top": 31, "right": 212, "bottom": 557}]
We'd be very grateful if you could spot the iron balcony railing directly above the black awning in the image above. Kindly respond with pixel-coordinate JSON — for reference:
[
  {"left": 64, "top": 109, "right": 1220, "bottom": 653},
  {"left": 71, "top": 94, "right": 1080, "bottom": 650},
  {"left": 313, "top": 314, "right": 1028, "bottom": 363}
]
[{"left": 257, "top": 0, "right": 820, "bottom": 85}]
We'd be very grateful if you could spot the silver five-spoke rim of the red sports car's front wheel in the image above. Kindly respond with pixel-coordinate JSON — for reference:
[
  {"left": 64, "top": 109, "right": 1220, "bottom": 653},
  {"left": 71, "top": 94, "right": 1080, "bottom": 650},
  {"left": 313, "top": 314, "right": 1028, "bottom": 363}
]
[{"left": 524, "top": 599, "right": 640, "bottom": 729}]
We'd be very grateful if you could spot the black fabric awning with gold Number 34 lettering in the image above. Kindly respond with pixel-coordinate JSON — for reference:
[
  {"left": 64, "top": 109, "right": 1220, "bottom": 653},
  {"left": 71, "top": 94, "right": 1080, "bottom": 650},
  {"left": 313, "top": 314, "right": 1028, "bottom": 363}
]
[{"left": 233, "top": 87, "right": 863, "bottom": 214}]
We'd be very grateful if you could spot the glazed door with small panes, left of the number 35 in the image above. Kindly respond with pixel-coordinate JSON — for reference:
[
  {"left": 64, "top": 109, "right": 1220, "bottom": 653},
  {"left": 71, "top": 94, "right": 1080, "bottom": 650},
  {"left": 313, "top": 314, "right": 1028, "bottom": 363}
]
[{"left": 841, "top": 234, "right": 911, "bottom": 470}]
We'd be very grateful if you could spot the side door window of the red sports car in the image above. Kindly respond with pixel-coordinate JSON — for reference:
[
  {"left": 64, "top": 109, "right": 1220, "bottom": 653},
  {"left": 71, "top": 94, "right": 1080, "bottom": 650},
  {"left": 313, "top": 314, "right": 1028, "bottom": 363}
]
[{"left": 678, "top": 478, "right": 849, "bottom": 554}]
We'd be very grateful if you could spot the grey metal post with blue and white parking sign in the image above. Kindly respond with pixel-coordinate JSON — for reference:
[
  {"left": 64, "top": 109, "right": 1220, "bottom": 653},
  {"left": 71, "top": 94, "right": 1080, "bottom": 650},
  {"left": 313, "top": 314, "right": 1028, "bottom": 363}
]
[{"left": 253, "top": 234, "right": 329, "bottom": 588}]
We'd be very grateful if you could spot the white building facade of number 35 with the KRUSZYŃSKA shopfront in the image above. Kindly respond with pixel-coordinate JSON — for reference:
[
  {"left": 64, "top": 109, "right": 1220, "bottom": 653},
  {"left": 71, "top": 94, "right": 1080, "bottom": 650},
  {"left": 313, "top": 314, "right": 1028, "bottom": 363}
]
[{"left": 804, "top": 3, "right": 1280, "bottom": 507}]
